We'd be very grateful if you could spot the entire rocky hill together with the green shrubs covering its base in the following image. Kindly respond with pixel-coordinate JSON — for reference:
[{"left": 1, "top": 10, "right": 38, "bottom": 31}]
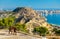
[{"left": 0, "top": 7, "right": 52, "bottom": 35}]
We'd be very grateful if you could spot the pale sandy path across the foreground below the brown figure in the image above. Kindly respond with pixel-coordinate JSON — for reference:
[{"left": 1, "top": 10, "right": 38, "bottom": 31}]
[{"left": 0, "top": 30, "right": 40, "bottom": 39}]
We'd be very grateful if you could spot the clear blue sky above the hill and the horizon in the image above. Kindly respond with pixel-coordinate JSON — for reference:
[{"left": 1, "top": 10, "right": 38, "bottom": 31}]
[{"left": 0, "top": 0, "right": 60, "bottom": 9}]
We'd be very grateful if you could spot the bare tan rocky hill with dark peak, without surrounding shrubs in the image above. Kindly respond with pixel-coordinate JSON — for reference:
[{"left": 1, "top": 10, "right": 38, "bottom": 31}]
[{"left": 13, "top": 7, "right": 51, "bottom": 33}]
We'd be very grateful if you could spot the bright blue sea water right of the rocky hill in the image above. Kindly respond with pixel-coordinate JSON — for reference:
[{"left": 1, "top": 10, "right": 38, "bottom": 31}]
[{"left": 45, "top": 13, "right": 60, "bottom": 25}]
